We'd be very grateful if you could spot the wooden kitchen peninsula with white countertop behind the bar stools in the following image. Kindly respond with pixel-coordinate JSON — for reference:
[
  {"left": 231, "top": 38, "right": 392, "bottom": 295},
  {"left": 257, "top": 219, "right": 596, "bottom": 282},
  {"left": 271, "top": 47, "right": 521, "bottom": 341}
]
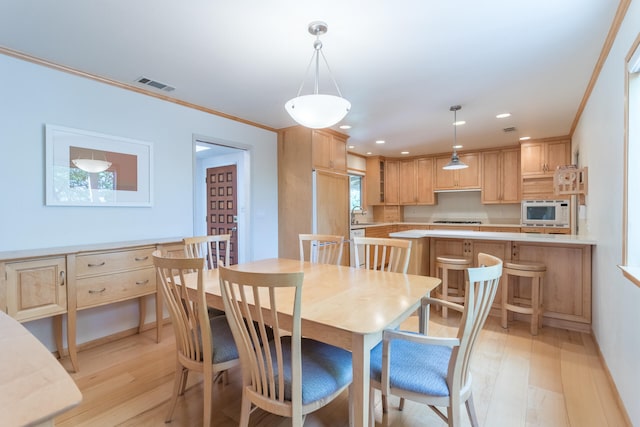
[{"left": 389, "top": 230, "right": 596, "bottom": 332}]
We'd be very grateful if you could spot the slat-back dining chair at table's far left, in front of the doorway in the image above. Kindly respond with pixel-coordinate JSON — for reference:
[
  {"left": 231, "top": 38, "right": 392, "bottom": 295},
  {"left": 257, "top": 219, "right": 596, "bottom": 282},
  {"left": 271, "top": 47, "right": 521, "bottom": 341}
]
[{"left": 182, "top": 234, "right": 231, "bottom": 317}]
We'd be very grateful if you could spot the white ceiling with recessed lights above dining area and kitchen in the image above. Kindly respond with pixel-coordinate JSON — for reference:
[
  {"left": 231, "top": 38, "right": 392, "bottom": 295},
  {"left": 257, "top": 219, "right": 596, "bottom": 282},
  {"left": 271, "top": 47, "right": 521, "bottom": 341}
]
[{"left": 0, "top": 0, "right": 618, "bottom": 156}]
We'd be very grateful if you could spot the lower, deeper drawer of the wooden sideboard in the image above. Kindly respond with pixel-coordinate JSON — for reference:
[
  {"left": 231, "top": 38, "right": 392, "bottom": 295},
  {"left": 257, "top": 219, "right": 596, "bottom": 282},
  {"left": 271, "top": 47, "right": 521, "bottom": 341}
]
[{"left": 76, "top": 268, "right": 156, "bottom": 309}]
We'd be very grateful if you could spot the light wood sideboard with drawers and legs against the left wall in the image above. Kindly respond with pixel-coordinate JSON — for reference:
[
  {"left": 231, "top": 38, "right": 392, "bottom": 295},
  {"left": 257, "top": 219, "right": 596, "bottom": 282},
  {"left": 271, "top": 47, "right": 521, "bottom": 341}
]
[{"left": 0, "top": 239, "right": 182, "bottom": 371}]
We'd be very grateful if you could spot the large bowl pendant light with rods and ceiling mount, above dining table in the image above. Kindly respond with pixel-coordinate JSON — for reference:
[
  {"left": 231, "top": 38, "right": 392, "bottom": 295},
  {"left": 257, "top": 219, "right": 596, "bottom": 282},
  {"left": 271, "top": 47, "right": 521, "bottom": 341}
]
[{"left": 284, "top": 21, "right": 351, "bottom": 129}]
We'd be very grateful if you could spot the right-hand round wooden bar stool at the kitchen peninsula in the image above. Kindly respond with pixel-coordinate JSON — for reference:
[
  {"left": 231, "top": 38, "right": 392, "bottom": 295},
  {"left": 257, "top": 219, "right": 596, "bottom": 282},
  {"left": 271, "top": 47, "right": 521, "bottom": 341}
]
[{"left": 502, "top": 261, "right": 547, "bottom": 335}]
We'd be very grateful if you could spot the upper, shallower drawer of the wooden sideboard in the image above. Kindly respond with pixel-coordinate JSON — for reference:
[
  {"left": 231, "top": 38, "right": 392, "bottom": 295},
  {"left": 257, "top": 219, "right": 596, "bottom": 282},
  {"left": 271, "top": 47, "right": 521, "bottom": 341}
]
[{"left": 76, "top": 246, "right": 155, "bottom": 277}]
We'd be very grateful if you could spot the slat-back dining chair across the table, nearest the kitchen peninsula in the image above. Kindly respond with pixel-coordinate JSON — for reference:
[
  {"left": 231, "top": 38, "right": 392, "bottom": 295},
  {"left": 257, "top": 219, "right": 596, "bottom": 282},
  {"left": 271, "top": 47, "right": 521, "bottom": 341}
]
[{"left": 353, "top": 237, "right": 411, "bottom": 273}]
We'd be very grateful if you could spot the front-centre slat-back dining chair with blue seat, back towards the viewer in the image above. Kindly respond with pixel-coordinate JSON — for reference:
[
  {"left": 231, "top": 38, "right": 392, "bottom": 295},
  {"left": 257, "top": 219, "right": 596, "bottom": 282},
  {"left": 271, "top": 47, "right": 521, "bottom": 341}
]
[{"left": 219, "top": 267, "right": 353, "bottom": 426}]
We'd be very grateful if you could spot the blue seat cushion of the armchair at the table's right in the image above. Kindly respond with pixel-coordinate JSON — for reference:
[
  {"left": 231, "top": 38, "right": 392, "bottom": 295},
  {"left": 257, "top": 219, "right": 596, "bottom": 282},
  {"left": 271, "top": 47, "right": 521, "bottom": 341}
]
[{"left": 371, "top": 332, "right": 451, "bottom": 396}]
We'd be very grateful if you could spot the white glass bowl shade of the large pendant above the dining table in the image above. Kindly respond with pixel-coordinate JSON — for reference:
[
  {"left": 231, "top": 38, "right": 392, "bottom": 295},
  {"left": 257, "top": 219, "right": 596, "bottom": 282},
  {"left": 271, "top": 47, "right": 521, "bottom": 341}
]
[{"left": 284, "top": 94, "right": 351, "bottom": 129}]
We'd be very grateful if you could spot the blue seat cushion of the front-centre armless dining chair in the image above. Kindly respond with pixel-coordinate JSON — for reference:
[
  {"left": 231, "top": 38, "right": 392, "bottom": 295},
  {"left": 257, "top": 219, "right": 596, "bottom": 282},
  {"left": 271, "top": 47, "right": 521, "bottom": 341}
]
[{"left": 271, "top": 336, "right": 353, "bottom": 405}]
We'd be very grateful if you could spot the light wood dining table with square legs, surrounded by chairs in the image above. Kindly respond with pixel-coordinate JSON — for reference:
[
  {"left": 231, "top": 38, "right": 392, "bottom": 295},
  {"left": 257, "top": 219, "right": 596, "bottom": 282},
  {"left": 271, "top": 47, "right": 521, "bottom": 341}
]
[{"left": 188, "top": 258, "right": 440, "bottom": 426}]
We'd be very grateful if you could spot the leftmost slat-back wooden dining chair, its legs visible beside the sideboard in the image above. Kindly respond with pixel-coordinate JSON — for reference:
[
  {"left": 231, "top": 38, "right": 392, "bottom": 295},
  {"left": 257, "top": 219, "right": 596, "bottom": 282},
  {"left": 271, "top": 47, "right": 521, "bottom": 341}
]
[{"left": 153, "top": 251, "right": 240, "bottom": 426}]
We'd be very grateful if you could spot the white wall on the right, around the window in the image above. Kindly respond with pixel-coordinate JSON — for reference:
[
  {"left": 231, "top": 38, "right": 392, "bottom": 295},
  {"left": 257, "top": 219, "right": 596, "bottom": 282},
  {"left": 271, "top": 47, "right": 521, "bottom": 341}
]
[{"left": 573, "top": 2, "right": 640, "bottom": 425}]
